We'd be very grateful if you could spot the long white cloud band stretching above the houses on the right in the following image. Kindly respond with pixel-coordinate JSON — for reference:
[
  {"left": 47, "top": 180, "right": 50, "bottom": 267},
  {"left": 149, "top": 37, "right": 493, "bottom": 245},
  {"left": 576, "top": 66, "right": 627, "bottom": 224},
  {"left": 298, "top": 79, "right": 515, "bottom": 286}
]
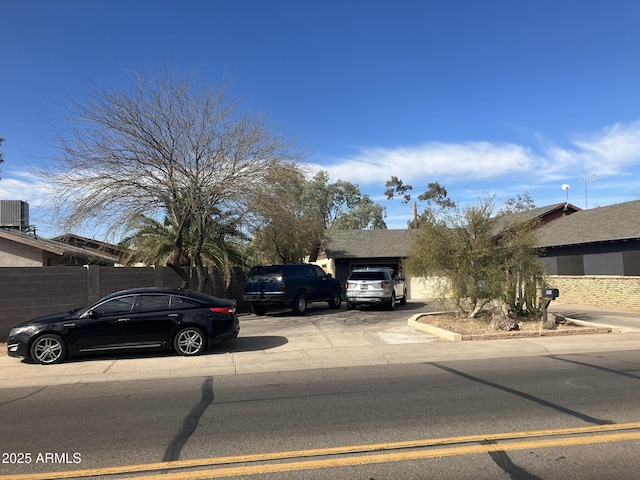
[{"left": 311, "top": 121, "right": 640, "bottom": 189}]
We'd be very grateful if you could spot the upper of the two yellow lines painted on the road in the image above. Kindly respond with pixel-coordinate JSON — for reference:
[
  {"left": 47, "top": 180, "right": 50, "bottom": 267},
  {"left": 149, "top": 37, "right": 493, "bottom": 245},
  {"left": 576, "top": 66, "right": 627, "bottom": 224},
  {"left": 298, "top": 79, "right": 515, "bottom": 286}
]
[{"left": 0, "top": 422, "right": 640, "bottom": 480}]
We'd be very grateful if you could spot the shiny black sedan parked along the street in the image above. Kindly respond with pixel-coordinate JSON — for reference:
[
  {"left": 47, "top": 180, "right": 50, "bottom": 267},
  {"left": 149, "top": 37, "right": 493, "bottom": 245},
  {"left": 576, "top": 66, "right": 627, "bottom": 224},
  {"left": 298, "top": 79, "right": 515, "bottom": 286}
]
[{"left": 7, "top": 288, "right": 240, "bottom": 364}]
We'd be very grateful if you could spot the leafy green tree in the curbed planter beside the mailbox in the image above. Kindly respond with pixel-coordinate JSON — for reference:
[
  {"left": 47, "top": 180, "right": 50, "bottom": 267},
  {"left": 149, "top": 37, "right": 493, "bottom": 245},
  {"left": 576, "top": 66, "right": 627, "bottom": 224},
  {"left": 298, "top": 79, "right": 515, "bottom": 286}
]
[{"left": 405, "top": 193, "right": 542, "bottom": 317}]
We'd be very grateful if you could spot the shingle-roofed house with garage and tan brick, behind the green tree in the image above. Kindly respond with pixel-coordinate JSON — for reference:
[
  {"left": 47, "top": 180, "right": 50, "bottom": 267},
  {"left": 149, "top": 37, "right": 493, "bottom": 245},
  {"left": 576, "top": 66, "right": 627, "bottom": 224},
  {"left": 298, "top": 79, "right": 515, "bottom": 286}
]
[{"left": 315, "top": 201, "right": 640, "bottom": 311}]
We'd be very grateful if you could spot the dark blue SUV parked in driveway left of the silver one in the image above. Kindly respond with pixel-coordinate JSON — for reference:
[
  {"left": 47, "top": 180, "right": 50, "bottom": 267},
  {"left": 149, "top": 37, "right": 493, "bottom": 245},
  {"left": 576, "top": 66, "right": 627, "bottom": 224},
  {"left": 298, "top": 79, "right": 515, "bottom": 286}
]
[{"left": 242, "top": 263, "right": 342, "bottom": 315}]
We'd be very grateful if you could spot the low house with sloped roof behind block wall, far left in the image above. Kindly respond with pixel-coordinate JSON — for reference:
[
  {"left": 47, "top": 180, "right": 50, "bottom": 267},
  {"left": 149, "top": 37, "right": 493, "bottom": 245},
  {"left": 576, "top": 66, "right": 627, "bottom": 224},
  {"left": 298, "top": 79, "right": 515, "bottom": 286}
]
[{"left": 0, "top": 228, "right": 118, "bottom": 267}]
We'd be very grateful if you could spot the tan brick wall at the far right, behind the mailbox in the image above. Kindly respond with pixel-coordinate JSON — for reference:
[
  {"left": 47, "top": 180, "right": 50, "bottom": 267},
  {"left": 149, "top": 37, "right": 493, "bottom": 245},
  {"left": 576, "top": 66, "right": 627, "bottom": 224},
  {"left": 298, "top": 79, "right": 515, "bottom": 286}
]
[{"left": 547, "top": 275, "right": 640, "bottom": 312}]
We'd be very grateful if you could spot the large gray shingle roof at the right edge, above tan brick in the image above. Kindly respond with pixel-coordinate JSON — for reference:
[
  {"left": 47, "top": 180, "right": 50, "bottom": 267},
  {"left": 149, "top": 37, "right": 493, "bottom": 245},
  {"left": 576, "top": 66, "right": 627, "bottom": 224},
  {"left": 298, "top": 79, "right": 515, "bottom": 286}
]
[{"left": 537, "top": 200, "right": 640, "bottom": 247}]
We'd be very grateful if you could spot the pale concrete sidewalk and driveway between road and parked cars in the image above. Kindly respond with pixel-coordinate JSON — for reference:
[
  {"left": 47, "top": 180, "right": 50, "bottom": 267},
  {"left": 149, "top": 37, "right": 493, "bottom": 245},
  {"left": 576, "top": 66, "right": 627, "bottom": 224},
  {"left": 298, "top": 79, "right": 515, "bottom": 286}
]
[{"left": 0, "top": 305, "right": 640, "bottom": 388}]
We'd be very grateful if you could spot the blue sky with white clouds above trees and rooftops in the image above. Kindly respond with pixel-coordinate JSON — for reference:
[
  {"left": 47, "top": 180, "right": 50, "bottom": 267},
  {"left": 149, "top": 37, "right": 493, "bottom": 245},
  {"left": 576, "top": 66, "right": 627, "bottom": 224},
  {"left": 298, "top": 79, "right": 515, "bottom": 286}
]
[{"left": 0, "top": 0, "right": 640, "bottom": 235}]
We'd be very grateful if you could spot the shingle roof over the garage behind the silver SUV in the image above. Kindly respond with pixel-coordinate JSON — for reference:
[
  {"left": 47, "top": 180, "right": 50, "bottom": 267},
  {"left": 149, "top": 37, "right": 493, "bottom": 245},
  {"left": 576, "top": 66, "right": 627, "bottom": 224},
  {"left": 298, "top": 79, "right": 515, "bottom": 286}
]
[{"left": 325, "top": 229, "right": 414, "bottom": 258}]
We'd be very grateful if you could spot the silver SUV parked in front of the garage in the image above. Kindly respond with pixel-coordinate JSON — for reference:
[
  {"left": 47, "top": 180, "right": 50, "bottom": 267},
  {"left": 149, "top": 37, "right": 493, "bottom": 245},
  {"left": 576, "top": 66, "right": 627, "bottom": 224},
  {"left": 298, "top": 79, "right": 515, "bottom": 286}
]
[{"left": 345, "top": 267, "right": 407, "bottom": 310}]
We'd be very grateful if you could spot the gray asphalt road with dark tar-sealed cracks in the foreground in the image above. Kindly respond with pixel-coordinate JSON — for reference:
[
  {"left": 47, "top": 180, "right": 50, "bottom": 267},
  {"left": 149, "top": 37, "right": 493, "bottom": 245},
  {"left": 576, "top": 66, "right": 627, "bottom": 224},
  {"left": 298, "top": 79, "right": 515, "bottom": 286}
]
[{"left": 0, "top": 351, "right": 640, "bottom": 480}]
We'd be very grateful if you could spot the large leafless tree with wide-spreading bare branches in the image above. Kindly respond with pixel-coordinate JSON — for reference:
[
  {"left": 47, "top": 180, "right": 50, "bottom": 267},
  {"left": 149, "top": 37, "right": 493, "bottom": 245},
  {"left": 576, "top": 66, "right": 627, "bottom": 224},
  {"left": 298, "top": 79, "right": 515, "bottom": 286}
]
[{"left": 35, "top": 67, "right": 301, "bottom": 287}]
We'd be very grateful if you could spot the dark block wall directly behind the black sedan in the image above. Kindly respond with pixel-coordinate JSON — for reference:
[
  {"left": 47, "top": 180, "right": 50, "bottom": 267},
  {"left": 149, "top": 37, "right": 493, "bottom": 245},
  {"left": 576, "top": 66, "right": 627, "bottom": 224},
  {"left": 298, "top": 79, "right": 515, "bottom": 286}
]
[{"left": 0, "top": 265, "right": 248, "bottom": 342}]
